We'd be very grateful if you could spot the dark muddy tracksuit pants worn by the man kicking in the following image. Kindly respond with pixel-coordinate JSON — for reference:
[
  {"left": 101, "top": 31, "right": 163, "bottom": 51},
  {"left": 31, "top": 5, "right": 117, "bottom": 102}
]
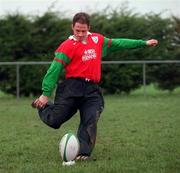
[{"left": 39, "top": 78, "right": 104, "bottom": 156}]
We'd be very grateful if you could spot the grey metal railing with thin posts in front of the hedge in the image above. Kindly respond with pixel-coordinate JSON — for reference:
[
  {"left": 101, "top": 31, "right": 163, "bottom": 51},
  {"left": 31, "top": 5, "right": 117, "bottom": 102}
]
[{"left": 0, "top": 60, "right": 180, "bottom": 99}]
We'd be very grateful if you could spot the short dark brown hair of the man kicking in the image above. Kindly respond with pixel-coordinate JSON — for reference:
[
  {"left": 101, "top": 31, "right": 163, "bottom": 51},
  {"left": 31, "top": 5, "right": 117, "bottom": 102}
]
[{"left": 72, "top": 12, "right": 90, "bottom": 26}]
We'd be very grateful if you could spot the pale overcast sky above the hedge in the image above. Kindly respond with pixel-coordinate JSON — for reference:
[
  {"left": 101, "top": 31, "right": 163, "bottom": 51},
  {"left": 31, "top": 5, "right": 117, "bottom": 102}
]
[{"left": 0, "top": 0, "right": 180, "bottom": 17}]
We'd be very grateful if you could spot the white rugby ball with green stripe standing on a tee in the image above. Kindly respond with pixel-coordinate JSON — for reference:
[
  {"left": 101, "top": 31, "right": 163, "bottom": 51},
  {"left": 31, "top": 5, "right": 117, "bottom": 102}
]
[{"left": 59, "top": 133, "right": 80, "bottom": 162}]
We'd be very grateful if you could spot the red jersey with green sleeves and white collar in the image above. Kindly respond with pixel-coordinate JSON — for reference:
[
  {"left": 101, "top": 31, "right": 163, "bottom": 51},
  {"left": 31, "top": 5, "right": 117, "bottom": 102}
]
[{"left": 42, "top": 33, "right": 146, "bottom": 96}]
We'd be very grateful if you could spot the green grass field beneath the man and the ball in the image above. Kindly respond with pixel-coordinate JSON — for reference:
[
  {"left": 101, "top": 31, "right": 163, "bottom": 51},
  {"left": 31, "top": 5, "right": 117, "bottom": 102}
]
[{"left": 0, "top": 90, "right": 180, "bottom": 173}]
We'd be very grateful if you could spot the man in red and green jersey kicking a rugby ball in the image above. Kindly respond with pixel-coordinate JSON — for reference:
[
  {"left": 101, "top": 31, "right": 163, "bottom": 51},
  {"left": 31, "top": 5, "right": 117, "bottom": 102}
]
[{"left": 32, "top": 12, "right": 158, "bottom": 160}]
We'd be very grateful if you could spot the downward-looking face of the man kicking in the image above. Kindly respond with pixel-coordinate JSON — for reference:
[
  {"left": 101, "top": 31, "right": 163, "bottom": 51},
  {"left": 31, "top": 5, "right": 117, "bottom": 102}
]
[{"left": 72, "top": 22, "right": 90, "bottom": 41}]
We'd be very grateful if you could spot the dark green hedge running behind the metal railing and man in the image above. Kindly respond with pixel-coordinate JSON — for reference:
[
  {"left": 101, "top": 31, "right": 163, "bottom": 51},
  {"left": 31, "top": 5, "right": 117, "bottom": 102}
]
[{"left": 0, "top": 9, "right": 180, "bottom": 96}]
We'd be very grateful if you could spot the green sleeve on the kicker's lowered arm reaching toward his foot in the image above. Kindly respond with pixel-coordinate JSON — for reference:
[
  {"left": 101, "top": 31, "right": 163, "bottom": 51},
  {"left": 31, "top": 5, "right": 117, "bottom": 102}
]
[{"left": 42, "top": 52, "right": 70, "bottom": 96}]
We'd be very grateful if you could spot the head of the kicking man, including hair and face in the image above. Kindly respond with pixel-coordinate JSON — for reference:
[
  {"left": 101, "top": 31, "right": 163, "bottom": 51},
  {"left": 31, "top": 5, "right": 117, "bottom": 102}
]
[{"left": 72, "top": 12, "right": 90, "bottom": 41}]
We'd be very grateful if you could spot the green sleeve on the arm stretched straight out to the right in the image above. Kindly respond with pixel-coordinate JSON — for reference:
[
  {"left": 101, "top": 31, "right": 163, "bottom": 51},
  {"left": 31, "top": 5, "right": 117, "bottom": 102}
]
[{"left": 103, "top": 37, "right": 146, "bottom": 56}]
